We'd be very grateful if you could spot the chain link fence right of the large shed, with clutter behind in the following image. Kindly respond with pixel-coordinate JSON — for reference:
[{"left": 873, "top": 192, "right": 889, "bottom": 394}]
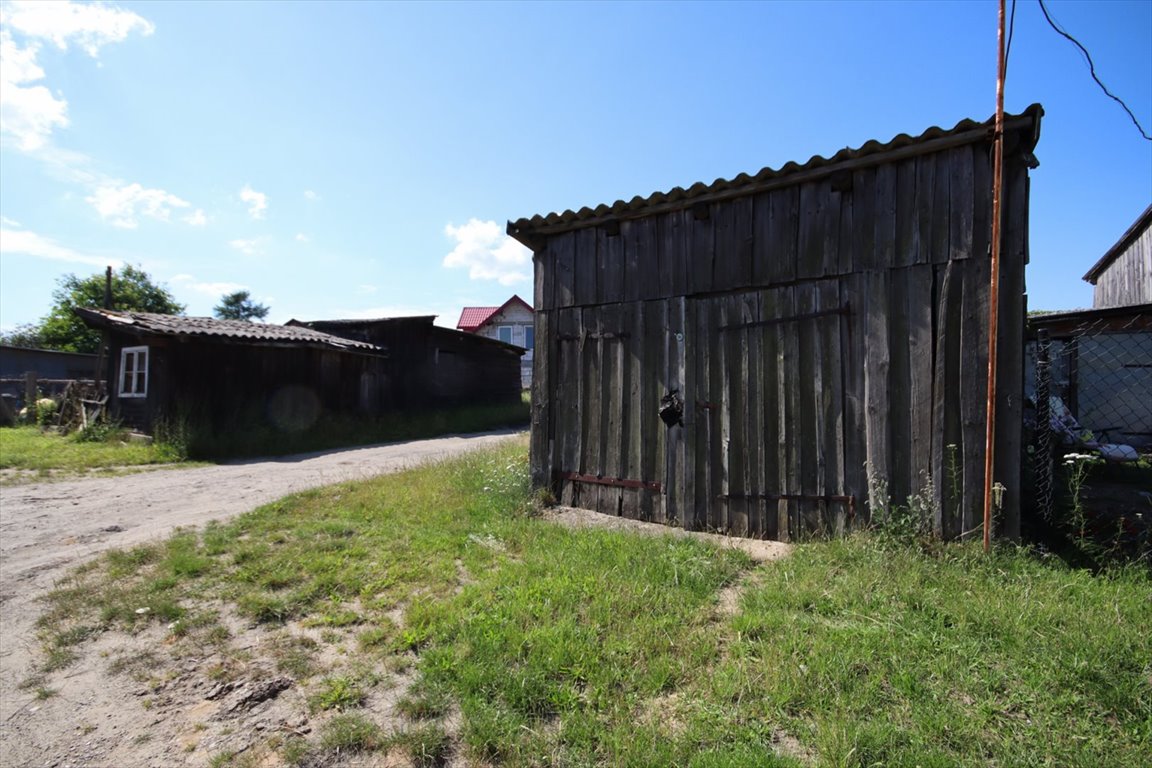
[{"left": 1025, "top": 307, "right": 1152, "bottom": 557}]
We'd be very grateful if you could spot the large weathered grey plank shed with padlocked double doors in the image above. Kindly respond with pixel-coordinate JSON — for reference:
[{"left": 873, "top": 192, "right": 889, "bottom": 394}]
[{"left": 508, "top": 105, "right": 1043, "bottom": 540}]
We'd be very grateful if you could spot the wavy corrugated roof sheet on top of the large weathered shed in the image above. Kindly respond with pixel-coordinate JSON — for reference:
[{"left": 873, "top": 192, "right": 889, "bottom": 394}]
[{"left": 508, "top": 104, "right": 1044, "bottom": 244}]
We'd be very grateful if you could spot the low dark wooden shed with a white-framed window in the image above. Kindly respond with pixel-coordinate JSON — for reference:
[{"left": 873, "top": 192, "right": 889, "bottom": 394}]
[{"left": 76, "top": 309, "right": 387, "bottom": 433}]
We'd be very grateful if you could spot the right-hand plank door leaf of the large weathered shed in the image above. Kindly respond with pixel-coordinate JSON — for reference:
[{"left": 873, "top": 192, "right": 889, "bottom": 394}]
[{"left": 689, "top": 281, "right": 855, "bottom": 540}]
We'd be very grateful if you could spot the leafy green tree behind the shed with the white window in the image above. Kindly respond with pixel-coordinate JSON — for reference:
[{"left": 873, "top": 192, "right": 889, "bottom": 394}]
[{"left": 39, "top": 264, "right": 184, "bottom": 352}]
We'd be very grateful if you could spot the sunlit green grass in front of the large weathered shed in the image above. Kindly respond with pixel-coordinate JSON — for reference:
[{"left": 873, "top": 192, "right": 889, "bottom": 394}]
[{"left": 37, "top": 440, "right": 1152, "bottom": 768}]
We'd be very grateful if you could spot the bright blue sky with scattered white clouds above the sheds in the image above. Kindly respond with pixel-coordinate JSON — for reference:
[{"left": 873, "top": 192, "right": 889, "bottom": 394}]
[{"left": 0, "top": 0, "right": 1152, "bottom": 329}]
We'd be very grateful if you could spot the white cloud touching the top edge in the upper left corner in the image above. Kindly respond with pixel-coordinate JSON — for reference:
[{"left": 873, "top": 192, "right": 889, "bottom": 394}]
[{"left": 0, "top": 0, "right": 156, "bottom": 59}]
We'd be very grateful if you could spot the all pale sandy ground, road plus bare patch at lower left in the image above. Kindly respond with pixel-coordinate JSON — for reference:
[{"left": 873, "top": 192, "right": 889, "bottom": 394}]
[{"left": 0, "top": 432, "right": 511, "bottom": 768}]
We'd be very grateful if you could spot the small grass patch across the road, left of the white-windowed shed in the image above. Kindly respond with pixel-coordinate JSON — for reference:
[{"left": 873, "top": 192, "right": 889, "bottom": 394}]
[{"left": 0, "top": 426, "right": 180, "bottom": 476}]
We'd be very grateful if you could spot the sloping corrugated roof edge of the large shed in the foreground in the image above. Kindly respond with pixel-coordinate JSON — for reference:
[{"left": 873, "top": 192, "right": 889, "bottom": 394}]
[{"left": 507, "top": 104, "right": 1044, "bottom": 250}]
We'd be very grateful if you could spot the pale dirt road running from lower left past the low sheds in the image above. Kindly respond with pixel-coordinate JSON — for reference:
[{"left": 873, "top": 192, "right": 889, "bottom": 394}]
[{"left": 0, "top": 432, "right": 511, "bottom": 766}]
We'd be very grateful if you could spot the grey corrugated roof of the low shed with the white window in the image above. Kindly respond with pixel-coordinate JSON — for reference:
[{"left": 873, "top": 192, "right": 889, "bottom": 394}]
[{"left": 75, "top": 309, "right": 384, "bottom": 352}]
